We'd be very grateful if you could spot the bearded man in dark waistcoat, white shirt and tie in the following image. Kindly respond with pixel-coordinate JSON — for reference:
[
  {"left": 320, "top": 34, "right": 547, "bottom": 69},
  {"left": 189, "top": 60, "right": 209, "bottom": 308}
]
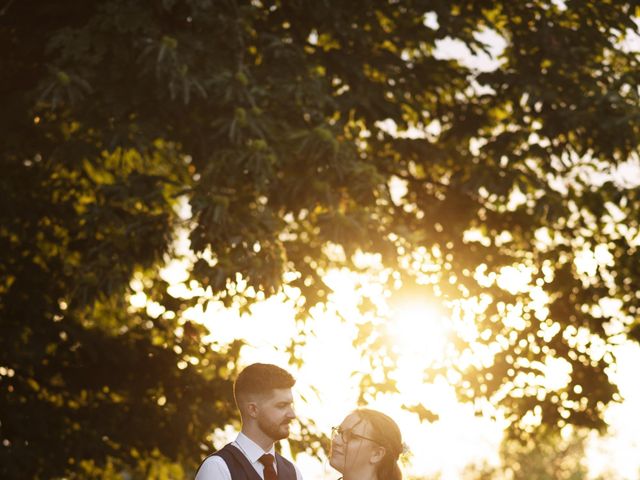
[{"left": 196, "top": 363, "right": 302, "bottom": 480}]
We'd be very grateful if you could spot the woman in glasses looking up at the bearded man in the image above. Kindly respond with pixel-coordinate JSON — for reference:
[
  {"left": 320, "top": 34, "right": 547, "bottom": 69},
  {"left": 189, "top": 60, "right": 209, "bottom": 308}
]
[{"left": 329, "top": 408, "right": 403, "bottom": 480}]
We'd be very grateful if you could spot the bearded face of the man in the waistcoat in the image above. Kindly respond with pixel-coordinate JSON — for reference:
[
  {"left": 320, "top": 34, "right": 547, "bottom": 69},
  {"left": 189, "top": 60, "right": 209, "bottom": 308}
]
[{"left": 256, "top": 388, "right": 296, "bottom": 442}]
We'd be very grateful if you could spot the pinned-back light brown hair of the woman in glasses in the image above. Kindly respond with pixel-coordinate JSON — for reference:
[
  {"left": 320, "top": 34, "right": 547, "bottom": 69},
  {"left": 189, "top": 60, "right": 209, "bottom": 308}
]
[{"left": 355, "top": 408, "right": 403, "bottom": 480}]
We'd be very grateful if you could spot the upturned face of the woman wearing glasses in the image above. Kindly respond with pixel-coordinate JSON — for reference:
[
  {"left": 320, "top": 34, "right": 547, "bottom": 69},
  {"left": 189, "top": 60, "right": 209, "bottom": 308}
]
[{"left": 329, "top": 413, "right": 380, "bottom": 474}]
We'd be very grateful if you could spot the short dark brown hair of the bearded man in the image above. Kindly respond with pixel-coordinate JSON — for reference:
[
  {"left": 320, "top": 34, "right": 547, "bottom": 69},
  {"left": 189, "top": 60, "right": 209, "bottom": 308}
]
[{"left": 233, "top": 363, "right": 296, "bottom": 408}]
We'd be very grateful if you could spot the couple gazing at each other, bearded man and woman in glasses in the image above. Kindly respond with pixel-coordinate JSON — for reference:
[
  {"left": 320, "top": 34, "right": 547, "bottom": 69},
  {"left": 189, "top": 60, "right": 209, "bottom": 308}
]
[{"left": 196, "top": 363, "right": 402, "bottom": 480}]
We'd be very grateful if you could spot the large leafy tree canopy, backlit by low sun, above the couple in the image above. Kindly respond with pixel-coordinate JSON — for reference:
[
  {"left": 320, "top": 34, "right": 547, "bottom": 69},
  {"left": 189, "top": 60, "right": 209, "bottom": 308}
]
[{"left": 0, "top": 0, "right": 640, "bottom": 477}]
